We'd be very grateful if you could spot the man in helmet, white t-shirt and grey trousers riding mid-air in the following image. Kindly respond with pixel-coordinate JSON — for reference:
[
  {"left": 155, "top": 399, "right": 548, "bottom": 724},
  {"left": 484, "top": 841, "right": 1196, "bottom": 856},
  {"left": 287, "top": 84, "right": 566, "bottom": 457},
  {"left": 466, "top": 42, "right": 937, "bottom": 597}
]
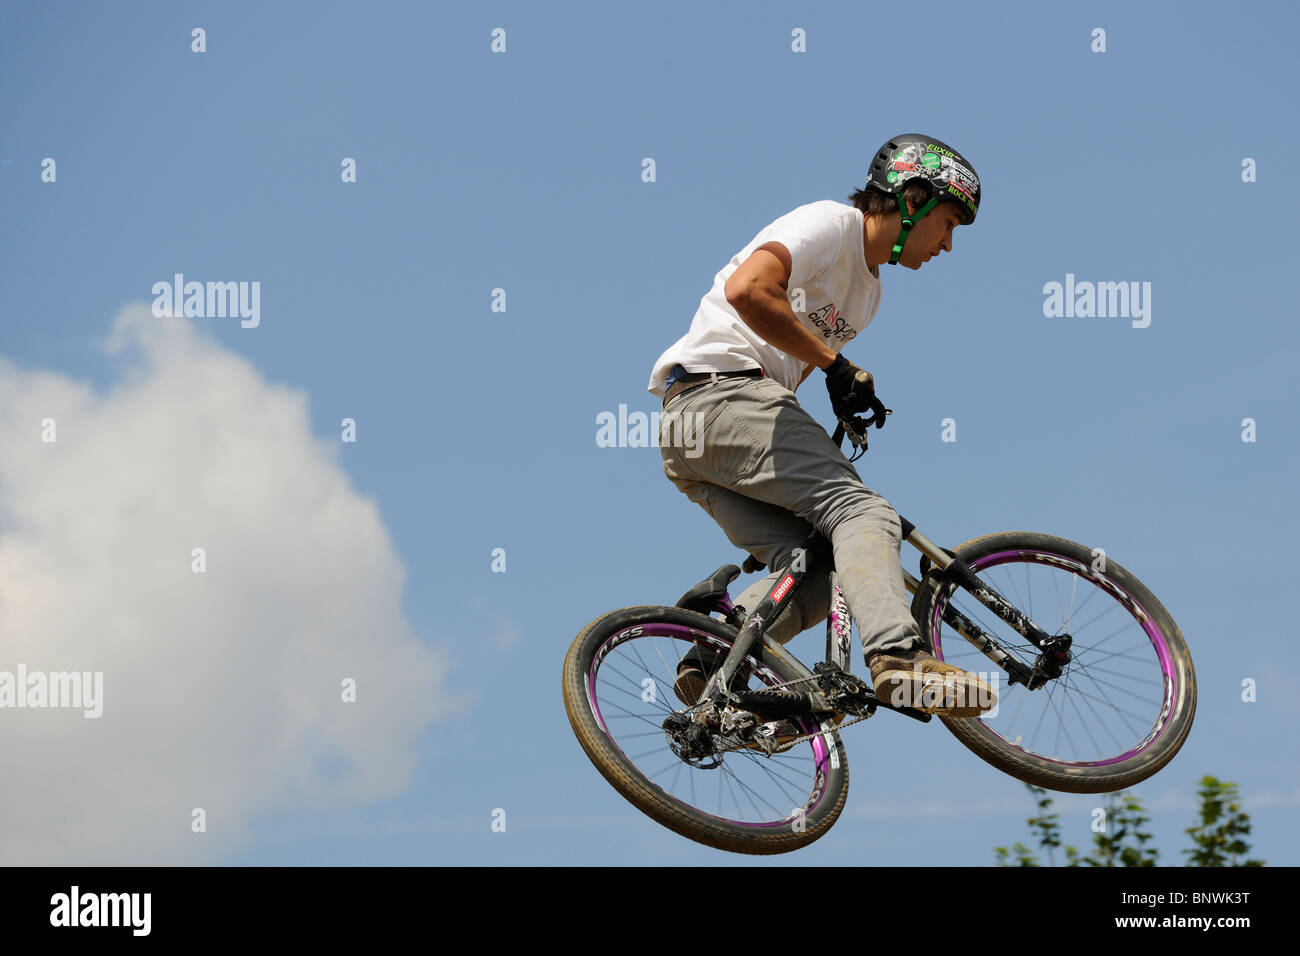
[{"left": 649, "top": 134, "right": 997, "bottom": 717}]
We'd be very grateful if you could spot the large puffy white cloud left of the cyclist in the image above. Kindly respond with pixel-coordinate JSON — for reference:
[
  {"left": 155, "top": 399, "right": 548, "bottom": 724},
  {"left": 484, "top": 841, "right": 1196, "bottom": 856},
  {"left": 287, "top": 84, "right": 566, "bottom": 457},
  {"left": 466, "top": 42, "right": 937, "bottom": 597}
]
[{"left": 0, "top": 307, "right": 454, "bottom": 865}]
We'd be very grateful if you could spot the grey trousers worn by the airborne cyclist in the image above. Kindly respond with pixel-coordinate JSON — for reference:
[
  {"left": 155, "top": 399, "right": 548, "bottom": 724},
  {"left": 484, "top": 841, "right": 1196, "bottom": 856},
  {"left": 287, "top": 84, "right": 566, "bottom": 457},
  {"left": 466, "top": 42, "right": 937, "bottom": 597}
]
[{"left": 659, "top": 377, "right": 924, "bottom": 654}]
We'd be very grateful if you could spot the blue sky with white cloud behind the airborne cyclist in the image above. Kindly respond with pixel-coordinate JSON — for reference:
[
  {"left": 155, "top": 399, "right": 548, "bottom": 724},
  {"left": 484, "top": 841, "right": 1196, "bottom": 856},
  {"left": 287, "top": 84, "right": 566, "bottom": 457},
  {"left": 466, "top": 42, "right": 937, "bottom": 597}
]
[{"left": 0, "top": 1, "right": 1300, "bottom": 865}]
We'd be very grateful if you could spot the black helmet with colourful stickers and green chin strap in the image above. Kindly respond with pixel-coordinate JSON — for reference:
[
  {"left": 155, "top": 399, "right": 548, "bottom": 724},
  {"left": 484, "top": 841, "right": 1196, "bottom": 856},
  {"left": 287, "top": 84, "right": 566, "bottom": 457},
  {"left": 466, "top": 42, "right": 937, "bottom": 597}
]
[{"left": 866, "top": 133, "right": 979, "bottom": 265}]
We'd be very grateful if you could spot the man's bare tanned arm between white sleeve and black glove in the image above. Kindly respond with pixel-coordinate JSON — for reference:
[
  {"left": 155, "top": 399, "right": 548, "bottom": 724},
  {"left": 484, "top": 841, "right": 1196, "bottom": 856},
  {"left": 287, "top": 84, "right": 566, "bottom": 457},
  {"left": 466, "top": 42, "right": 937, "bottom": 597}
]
[{"left": 723, "top": 242, "right": 836, "bottom": 384}]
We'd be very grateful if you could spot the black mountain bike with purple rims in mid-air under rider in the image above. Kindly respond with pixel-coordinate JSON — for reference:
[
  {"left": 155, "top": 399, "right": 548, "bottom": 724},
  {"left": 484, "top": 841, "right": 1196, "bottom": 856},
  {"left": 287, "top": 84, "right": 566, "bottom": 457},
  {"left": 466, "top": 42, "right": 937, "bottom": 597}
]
[{"left": 563, "top": 401, "right": 1196, "bottom": 853}]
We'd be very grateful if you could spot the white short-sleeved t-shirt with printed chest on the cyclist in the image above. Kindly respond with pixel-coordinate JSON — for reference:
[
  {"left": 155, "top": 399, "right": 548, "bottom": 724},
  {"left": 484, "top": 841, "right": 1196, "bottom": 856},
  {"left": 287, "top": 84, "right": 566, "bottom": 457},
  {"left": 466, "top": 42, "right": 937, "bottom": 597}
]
[{"left": 647, "top": 199, "right": 880, "bottom": 398}]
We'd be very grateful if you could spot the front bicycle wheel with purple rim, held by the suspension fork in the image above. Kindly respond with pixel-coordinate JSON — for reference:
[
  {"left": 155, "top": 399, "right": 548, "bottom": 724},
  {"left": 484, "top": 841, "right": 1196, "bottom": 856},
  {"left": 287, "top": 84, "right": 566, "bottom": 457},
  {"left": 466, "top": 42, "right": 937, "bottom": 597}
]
[{"left": 913, "top": 531, "right": 1196, "bottom": 793}]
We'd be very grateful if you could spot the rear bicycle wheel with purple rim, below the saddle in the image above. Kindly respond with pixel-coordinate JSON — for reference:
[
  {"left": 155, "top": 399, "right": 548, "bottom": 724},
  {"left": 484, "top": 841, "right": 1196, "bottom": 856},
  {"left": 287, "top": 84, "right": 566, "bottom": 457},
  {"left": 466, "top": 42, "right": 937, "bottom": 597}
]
[{"left": 563, "top": 606, "right": 849, "bottom": 853}]
